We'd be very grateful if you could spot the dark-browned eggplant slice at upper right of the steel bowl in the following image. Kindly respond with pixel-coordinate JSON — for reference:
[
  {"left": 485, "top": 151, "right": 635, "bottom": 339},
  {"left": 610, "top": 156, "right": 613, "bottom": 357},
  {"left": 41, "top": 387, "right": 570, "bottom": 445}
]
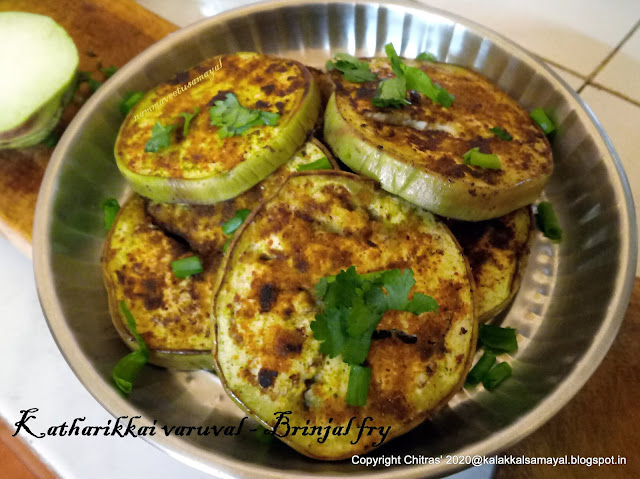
[{"left": 324, "top": 58, "right": 553, "bottom": 221}]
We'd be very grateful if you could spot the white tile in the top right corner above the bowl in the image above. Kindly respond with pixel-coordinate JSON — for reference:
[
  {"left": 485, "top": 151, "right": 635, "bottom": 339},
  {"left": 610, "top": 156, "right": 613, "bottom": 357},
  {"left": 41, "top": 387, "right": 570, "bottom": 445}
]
[{"left": 419, "top": 0, "right": 640, "bottom": 76}]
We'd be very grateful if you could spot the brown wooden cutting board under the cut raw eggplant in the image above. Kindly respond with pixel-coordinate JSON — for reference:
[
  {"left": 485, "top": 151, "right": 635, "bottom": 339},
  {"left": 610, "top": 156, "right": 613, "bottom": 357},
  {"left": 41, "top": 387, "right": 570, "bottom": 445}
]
[{"left": 0, "top": 0, "right": 177, "bottom": 255}]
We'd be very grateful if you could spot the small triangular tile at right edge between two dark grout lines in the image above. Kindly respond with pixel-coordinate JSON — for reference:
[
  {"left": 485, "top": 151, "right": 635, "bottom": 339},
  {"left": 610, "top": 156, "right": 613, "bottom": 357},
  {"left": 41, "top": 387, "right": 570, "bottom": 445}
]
[{"left": 594, "top": 26, "right": 640, "bottom": 101}]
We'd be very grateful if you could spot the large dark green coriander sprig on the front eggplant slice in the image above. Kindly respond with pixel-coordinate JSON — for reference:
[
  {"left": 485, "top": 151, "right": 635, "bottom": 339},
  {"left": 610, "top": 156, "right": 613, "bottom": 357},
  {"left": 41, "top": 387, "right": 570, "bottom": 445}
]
[{"left": 311, "top": 266, "right": 438, "bottom": 406}]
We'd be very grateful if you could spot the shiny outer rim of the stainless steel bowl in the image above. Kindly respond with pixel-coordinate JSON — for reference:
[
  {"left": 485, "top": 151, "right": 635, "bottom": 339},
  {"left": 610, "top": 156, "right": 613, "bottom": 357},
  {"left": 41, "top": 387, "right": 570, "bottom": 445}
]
[{"left": 33, "top": 0, "right": 638, "bottom": 479}]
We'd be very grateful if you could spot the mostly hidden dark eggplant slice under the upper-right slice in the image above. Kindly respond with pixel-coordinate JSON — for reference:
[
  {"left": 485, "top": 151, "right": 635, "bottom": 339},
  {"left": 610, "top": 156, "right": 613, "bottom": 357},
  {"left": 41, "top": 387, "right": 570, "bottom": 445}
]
[{"left": 447, "top": 206, "right": 535, "bottom": 323}]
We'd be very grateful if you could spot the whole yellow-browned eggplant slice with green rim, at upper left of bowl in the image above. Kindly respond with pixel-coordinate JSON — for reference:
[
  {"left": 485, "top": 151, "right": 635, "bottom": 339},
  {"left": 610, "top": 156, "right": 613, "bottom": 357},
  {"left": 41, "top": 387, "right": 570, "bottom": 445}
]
[{"left": 115, "top": 53, "right": 320, "bottom": 204}]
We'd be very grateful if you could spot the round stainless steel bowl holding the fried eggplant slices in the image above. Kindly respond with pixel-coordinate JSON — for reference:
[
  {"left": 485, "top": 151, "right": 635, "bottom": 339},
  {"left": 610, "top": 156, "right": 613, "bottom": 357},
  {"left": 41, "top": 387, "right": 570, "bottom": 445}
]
[{"left": 33, "top": 1, "right": 638, "bottom": 478}]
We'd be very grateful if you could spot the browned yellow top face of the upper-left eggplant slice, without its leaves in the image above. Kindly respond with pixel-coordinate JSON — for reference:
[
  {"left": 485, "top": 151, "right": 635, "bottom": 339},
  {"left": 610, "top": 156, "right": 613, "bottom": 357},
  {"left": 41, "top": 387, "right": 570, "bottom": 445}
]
[{"left": 116, "top": 53, "right": 315, "bottom": 178}]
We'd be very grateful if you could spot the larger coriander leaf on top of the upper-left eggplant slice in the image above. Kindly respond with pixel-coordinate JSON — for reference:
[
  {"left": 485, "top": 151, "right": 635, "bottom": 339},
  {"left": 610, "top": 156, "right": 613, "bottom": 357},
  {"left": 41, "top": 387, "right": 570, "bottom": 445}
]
[{"left": 209, "top": 93, "right": 280, "bottom": 138}]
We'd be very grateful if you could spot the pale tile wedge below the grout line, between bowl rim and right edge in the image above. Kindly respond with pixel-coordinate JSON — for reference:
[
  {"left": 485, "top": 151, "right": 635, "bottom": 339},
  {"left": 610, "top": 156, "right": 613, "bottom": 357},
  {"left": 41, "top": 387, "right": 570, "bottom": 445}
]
[{"left": 582, "top": 86, "right": 640, "bottom": 276}]
